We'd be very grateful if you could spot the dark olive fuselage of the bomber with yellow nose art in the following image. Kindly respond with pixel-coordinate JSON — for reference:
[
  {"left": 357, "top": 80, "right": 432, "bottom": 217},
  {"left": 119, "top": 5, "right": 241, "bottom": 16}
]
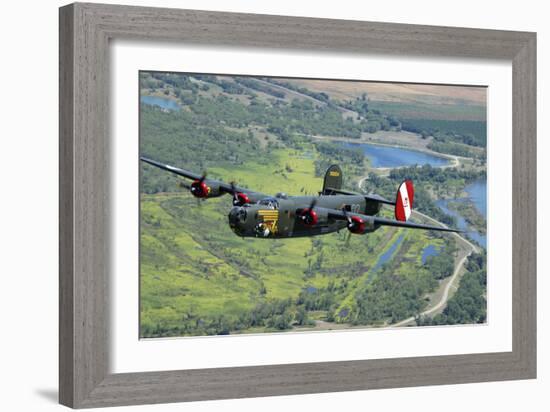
[{"left": 228, "top": 194, "right": 381, "bottom": 239}]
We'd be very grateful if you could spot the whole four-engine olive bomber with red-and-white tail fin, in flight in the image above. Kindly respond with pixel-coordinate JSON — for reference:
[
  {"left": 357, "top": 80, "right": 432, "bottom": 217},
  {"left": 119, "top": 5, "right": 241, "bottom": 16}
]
[{"left": 141, "top": 157, "right": 459, "bottom": 239}]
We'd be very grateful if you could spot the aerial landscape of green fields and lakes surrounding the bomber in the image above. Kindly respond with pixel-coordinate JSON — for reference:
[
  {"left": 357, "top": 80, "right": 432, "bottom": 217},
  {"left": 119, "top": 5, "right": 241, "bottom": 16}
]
[{"left": 139, "top": 71, "right": 487, "bottom": 338}]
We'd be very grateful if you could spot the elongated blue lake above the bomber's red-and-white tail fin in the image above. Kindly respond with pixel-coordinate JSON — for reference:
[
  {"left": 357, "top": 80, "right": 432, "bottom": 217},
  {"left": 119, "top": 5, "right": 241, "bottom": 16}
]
[{"left": 342, "top": 142, "right": 449, "bottom": 167}]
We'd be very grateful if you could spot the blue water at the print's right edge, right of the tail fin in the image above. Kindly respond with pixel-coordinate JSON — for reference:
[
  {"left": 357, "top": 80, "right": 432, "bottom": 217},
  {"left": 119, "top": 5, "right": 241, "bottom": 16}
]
[{"left": 436, "top": 180, "right": 487, "bottom": 249}]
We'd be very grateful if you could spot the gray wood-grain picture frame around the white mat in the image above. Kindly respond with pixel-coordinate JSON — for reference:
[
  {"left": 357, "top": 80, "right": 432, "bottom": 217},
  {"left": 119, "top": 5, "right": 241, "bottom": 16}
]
[{"left": 59, "top": 3, "right": 536, "bottom": 408}]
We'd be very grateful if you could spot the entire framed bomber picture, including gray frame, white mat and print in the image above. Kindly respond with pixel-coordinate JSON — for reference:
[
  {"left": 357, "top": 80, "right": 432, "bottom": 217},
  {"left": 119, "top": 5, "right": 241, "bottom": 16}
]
[{"left": 60, "top": 3, "right": 536, "bottom": 408}]
